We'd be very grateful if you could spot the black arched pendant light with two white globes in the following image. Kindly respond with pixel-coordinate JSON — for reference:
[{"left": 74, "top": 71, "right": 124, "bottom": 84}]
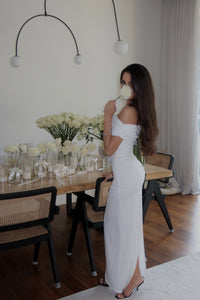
[{"left": 11, "top": 0, "right": 82, "bottom": 67}]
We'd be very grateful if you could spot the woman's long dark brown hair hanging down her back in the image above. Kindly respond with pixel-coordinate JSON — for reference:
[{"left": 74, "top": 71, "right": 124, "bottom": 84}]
[{"left": 120, "top": 64, "right": 159, "bottom": 155}]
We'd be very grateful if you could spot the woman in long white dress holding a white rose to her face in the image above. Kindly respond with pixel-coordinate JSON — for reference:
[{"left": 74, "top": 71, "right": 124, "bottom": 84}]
[{"left": 99, "top": 64, "right": 158, "bottom": 299}]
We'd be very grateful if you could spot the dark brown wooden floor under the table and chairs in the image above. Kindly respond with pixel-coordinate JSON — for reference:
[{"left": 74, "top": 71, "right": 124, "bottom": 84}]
[{"left": 0, "top": 195, "right": 200, "bottom": 300}]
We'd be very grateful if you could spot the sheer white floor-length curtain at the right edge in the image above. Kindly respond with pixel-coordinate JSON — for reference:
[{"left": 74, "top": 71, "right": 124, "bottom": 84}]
[{"left": 158, "top": 0, "right": 200, "bottom": 194}]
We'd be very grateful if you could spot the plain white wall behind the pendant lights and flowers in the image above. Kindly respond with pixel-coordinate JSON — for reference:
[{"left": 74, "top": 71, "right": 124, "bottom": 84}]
[{"left": 0, "top": 0, "right": 162, "bottom": 153}]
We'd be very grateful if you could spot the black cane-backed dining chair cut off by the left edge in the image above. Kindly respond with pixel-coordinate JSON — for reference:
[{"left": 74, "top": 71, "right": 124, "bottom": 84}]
[{"left": 0, "top": 187, "right": 60, "bottom": 288}]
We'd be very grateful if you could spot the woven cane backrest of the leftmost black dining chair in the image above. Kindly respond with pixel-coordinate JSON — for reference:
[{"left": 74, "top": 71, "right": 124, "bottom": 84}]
[{"left": 0, "top": 187, "right": 57, "bottom": 232}]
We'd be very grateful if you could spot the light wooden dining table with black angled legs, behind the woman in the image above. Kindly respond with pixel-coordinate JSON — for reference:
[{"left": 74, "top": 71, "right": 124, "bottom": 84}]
[{"left": 0, "top": 164, "right": 173, "bottom": 231}]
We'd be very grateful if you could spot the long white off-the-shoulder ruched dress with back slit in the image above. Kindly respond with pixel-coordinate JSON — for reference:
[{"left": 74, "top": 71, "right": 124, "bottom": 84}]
[{"left": 104, "top": 115, "right": 146, "bottom": 293}]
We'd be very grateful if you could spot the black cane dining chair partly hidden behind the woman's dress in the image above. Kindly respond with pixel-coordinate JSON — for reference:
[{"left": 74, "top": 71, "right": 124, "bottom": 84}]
[{"left": 67, "top": 177, "right": 112, "bottom": 276}]
